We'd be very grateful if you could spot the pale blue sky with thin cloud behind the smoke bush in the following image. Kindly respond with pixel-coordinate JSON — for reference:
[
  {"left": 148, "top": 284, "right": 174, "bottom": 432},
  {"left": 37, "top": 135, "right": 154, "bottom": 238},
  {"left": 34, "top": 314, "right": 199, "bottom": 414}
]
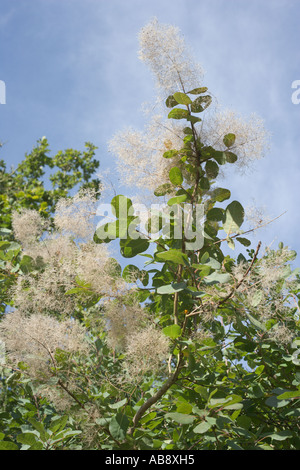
[{"left": 0, "top": 0, "right": 300, "bottom": 253}]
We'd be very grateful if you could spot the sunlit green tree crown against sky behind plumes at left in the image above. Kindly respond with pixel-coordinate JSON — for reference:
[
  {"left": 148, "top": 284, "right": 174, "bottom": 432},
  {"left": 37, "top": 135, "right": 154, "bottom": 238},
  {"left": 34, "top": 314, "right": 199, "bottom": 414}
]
[{"left": 0, "top": 137, "right": 100, "bottom": 229}]
